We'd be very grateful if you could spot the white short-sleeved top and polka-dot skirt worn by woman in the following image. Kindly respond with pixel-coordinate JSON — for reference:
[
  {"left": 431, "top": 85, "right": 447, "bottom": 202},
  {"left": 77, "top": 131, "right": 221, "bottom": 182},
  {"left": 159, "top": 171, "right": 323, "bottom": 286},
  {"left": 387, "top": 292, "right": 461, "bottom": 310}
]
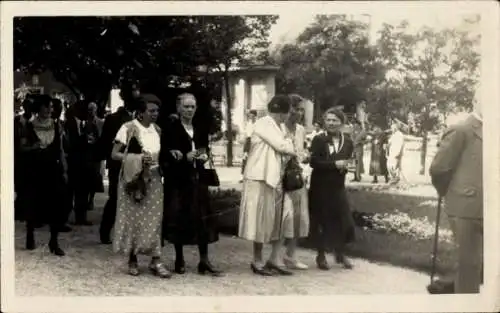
[{"left": 113, "top": 120, "right": 163, "bottom": 256}]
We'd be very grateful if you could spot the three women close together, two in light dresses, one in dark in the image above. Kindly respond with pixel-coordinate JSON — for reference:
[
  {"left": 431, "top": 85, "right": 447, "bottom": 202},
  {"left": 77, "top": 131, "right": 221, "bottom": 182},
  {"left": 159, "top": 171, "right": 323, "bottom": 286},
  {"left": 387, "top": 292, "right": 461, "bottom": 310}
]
[{"left": 239, "top": 95, "right": 354, "bottom": 276}]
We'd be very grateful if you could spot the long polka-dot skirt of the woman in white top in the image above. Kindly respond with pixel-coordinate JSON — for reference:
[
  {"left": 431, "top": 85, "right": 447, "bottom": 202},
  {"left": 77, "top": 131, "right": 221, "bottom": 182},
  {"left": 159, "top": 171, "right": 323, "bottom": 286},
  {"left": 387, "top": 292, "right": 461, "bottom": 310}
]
[{"left": 113, "top": 170, "right": 163, "bottom": 256}]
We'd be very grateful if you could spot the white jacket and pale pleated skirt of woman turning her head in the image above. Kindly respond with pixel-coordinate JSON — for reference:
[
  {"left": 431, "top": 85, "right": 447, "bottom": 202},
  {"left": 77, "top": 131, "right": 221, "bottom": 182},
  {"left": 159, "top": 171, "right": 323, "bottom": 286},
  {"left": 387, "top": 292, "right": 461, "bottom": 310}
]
[{"left": 238, "top": 116, "right": 294, "bottom": 243}]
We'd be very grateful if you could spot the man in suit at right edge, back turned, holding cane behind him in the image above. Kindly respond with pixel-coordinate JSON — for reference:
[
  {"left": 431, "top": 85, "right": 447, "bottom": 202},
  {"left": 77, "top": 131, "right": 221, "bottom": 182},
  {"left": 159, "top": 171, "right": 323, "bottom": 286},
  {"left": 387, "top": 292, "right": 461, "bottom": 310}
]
[{"left": 428, "top": 107, "right": 483, "bottom": 293}]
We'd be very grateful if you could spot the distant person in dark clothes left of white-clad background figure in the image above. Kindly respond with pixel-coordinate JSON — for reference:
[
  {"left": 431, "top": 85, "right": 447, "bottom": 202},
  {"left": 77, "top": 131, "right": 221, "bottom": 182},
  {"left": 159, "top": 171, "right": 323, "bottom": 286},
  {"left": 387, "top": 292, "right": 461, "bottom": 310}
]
[{"left": 370, "top": 126, "right": 389, "bottom": 184}]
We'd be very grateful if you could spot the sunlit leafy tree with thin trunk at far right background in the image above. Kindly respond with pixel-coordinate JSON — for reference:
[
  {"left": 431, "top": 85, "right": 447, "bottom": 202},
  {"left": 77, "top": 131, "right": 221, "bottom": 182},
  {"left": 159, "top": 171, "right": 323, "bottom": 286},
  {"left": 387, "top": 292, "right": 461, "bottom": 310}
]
[{"left": 372, "top": 19, "right": 479, "bottom": 174}]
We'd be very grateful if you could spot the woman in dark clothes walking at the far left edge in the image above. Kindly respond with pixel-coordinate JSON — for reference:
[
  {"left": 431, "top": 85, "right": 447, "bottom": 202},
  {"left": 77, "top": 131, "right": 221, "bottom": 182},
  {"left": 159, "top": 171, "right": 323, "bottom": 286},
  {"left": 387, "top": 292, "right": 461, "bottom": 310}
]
[{"left": 21, "top": 95, "right": 67, "bottom": 256}]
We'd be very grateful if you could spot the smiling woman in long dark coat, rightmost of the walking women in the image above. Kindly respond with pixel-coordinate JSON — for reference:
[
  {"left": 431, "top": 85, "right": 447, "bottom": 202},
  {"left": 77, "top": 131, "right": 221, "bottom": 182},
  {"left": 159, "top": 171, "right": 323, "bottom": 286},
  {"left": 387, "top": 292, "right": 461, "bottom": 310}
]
[{"left": 309, "top": 109, "right": 354, "bottom": 270}]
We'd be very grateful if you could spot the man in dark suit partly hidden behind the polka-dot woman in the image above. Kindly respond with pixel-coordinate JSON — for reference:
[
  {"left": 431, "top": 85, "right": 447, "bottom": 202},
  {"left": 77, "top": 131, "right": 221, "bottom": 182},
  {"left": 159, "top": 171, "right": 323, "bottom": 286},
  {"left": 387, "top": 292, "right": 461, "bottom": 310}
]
[{"left": 98, "top": 84, "right": 140, "bottom": 244}]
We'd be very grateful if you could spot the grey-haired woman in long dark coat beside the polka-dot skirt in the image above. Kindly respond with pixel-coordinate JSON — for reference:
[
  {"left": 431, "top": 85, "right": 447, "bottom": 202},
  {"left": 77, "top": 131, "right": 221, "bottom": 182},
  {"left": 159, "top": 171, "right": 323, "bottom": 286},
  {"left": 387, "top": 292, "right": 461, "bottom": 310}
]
[{"left": 160, "top": 93, "right": 221, "bottom": 276}]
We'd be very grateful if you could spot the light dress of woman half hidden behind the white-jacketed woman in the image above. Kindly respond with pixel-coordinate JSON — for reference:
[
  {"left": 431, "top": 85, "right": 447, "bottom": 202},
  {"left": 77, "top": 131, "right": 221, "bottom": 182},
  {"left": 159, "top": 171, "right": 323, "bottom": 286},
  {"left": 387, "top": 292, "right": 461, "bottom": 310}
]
[{"left": 281, "top": 124, "right": 309, "bottom": 239}]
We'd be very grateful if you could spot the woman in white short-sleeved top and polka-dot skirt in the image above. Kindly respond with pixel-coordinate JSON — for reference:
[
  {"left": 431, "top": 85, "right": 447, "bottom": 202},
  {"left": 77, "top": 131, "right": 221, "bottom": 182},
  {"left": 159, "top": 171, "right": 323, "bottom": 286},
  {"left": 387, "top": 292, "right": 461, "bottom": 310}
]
[{"left": 112, "top": 95, "right": 171, "bottom": 278}]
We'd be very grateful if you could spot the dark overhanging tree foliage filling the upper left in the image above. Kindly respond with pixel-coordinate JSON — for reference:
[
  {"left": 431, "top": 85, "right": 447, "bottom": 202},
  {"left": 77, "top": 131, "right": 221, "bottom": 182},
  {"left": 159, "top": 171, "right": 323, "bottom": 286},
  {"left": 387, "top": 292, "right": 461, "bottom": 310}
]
[{"left": 14, "top": 16, "right": 276, "bottom": 105}]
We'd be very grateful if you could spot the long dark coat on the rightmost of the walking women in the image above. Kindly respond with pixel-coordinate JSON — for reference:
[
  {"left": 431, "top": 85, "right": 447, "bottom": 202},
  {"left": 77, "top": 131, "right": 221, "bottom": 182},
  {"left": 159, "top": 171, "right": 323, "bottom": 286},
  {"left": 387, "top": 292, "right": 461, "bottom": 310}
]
[{"left": 309, "top": 134, "right": 354, "bottom": 248}]
